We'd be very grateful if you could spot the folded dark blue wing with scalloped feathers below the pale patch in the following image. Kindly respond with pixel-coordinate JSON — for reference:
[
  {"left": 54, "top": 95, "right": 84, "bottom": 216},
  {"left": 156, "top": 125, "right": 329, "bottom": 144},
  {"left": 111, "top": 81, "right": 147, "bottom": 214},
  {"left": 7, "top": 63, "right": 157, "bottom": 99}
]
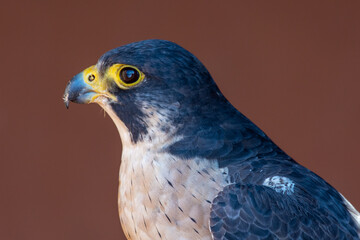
[{"left": 210, "top": 184, "right": 359, "bottom": 240}]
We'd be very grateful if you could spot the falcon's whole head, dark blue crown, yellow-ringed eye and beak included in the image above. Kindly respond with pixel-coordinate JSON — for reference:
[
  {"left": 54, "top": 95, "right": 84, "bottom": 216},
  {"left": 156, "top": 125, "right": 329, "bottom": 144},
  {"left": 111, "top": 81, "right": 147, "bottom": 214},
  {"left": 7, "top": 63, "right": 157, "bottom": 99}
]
[{"left": 64, "top": 40, "right": 222, "bottom": 143}]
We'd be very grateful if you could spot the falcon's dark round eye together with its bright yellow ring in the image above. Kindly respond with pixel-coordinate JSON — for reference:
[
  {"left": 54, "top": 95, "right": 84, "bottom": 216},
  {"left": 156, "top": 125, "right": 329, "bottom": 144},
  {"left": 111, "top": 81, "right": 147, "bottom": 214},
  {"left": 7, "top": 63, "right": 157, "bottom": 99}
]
[{"left": 108, "top": 64, "right": 145, "bottom": 89}]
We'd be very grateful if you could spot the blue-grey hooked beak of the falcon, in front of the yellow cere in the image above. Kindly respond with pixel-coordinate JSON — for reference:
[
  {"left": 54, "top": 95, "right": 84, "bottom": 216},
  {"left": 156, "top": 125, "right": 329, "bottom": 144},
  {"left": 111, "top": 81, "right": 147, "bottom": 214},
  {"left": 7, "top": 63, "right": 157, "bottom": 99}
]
[{"left": 63, "top": 72, "right": 99, "bottom": 108}]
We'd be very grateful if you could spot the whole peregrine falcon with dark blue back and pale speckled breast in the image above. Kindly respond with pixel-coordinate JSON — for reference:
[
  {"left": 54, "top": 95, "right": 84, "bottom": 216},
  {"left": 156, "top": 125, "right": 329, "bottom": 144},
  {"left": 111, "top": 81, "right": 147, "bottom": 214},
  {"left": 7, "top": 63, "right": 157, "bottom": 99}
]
[{"left": 64, "top": 40, "right": 360, "bottom": 240}]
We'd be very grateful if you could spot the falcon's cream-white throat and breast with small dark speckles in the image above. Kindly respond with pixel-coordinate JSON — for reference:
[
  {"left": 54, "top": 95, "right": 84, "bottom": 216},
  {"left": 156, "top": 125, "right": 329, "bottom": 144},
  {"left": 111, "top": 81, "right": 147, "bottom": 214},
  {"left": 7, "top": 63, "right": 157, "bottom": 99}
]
[{"left": 98, "top": 100, "right": 228, "bottom": 240}]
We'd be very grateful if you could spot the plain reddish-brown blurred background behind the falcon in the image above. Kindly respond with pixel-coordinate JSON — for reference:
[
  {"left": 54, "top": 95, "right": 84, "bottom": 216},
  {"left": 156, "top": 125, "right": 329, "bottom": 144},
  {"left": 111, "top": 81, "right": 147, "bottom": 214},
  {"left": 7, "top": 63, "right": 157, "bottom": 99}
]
[{"left": 0, "top": 0, "right": 360, "bottom": 240}]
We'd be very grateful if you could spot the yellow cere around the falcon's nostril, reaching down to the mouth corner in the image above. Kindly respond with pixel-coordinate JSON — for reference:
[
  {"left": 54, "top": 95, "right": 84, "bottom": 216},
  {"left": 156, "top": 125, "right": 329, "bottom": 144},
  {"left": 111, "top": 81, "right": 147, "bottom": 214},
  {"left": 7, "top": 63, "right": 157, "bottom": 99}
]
[{"left": 83, "top": 65, "right": 116, "bottom": 102}]
